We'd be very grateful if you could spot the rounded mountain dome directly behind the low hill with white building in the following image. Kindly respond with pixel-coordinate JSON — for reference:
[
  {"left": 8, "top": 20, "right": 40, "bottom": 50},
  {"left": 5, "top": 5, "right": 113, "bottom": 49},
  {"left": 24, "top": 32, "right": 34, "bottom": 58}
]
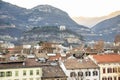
[{"left": 28, "top": 5, "right": 88, "bottom": 32}]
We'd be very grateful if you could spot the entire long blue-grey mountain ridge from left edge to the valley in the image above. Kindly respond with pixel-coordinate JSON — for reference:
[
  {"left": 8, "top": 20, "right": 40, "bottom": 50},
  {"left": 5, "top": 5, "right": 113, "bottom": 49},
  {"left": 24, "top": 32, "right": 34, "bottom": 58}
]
[{"left": 0, "top": 0, "right": 90, "bottom": 40}]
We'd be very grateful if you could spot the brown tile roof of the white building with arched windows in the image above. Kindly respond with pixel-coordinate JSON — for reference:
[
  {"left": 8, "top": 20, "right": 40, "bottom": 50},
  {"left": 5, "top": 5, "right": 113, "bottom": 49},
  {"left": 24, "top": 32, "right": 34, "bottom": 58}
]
[{"left": 64, "top": 58, "right": 98, "bottom": 69}]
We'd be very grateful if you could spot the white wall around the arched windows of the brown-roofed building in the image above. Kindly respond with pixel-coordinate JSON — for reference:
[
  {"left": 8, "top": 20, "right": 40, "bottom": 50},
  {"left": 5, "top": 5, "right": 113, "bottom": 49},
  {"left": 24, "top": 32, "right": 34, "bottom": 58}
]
[{"left": 60, "top": 61, "right": 100, "bottom": 80}]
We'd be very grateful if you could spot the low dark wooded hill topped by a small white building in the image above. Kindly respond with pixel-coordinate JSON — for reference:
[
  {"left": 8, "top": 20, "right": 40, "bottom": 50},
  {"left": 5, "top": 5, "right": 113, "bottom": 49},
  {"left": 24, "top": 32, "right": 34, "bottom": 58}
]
[{"left": 22, "top": 26, "right": 83, "bottom": 44}]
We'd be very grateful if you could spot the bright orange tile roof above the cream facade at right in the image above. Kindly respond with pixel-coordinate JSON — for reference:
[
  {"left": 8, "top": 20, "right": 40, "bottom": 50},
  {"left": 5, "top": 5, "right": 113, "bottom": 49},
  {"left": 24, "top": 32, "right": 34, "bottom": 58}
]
[{"left": 93, "top": 54, "right": 120, "bottom": 63}]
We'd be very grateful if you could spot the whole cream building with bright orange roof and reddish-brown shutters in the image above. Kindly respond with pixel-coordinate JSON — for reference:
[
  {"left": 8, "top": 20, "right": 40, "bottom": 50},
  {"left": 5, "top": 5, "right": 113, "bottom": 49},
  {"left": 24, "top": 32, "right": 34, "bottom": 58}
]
[{"left": 89, "top": 54, "right": 120, "bottom": 80}]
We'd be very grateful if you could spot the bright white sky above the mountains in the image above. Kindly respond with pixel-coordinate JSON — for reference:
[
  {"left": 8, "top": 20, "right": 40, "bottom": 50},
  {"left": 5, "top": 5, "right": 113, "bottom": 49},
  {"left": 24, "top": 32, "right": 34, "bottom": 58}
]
[{"left": 3, "top": 0, "right": 120, "bottom": 17}]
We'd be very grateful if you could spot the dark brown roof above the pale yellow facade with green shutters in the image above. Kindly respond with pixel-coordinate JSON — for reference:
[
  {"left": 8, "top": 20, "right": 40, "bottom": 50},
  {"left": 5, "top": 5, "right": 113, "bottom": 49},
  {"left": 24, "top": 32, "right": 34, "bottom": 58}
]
[{"left": 0, "top": 59, "right": 50, "bottom": 69}]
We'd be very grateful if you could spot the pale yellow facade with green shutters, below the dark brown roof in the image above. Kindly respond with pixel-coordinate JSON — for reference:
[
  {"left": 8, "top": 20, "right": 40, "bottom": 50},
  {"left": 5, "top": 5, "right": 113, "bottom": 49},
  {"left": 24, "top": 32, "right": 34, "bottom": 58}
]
[{"left": 0, "top": 67, "right": 42, "bottom": 80}]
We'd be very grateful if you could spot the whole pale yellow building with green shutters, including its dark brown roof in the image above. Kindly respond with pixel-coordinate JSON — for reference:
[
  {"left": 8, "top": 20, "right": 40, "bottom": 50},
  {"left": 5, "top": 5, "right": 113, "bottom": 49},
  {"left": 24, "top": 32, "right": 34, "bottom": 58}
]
[{"left": 0, "top": 54, "right": 42, "bottom": 80}]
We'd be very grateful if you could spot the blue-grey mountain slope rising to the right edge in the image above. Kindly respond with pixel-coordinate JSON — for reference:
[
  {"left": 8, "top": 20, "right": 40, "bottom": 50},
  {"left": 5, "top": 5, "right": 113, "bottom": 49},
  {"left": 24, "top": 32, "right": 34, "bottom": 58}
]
[{"left": 91, "top": 15, "right": 120, "bottom": 41}]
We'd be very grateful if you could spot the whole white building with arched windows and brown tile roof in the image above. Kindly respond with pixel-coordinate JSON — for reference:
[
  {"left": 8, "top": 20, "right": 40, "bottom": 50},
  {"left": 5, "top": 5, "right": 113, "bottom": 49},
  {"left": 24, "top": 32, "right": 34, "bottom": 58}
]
[{"left": 60, "top": 59, "right": 99, "bottom": 80}]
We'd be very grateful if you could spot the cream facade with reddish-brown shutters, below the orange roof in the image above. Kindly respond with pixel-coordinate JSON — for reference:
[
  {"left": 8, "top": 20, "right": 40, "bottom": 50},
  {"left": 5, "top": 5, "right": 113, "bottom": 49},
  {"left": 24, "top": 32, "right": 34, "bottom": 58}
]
[{"left": 98, "top": 63, "right": 120, "bottom": 80}]
